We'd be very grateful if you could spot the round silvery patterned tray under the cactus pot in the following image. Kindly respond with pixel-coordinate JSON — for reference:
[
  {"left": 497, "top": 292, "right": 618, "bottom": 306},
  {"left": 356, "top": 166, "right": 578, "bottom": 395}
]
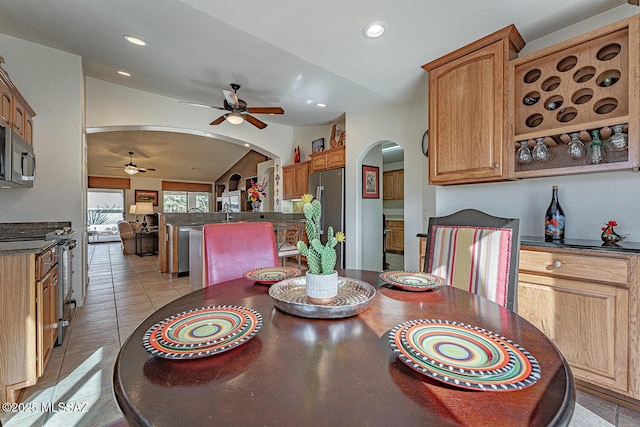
[{"left": 269, "top": 276, "right": 376, "bottom": 319}]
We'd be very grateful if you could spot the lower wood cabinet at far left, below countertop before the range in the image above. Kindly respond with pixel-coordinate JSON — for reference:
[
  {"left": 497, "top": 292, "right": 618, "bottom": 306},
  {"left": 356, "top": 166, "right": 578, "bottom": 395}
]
[{"left": 0, "top": 246, "right": 58, "bottom": 402}]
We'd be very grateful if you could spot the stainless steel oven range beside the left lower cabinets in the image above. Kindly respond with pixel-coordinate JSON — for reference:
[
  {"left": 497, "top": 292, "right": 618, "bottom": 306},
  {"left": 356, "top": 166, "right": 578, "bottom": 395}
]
[{"left": 45, "top": 229, "right": 77, "bottom": 345}]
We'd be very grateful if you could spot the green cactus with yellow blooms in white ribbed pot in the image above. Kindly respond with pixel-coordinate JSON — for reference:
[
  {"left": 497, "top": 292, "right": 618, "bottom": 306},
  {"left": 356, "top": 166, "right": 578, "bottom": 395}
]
[{"left": 297, "top": 194, "right": 345, "bottom": 304}]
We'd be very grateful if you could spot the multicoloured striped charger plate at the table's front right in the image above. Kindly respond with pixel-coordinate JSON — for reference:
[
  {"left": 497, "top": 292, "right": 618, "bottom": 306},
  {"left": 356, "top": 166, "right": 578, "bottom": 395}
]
[{"left": 389, "top": 319, "right": 540, "bottom": 391}]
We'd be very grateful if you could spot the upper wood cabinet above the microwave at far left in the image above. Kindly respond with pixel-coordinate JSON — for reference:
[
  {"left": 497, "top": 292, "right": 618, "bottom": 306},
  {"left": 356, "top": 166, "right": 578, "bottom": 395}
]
[{"left": 0, "top": 67, "right": 36, "bottom": 144}]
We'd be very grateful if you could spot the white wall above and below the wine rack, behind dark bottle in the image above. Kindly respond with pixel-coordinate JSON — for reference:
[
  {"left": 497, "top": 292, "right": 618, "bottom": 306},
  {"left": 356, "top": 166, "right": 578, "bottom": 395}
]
[{"left": 436, "top": 5, "right": 640, "bottom": 241}]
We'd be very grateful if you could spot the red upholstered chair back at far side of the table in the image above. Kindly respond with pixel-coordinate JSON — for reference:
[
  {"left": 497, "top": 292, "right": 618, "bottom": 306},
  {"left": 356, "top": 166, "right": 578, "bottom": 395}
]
[{"left": 202, "top": 222, "right": 278, "bottom": 286}]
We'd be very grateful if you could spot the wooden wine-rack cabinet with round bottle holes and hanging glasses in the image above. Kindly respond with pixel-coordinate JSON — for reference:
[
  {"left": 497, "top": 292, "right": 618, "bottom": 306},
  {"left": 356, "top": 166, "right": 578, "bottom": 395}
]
[{"left": 509, "top": 15, "right": 640, "bottom": 178}]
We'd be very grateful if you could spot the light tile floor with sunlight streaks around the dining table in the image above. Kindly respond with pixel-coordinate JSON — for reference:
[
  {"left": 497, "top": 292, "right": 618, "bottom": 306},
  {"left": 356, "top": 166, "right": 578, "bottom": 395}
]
[{"left": 0, "top": 243, "right": 640, "bottom": 427}]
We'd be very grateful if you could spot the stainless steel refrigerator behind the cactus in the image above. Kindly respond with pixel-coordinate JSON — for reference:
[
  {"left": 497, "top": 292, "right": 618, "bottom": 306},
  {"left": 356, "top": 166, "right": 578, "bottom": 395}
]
[{"left": 309, "top": 168, "right": 342, "bottom": 268}]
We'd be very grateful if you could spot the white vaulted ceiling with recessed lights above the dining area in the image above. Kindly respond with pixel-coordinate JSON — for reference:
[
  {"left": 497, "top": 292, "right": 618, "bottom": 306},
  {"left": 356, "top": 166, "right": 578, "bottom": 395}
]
[{"left": 0, "top": 0, "right": 634, "bottom": 181}]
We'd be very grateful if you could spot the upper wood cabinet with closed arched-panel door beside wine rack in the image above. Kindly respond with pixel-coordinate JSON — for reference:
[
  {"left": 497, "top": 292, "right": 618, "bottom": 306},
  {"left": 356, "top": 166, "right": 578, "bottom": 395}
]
[{"left": 422, "top": 25, "right": 525, "bottom": 184}]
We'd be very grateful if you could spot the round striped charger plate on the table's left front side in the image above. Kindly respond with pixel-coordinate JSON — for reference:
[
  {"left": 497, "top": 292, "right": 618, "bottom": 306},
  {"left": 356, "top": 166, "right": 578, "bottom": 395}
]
[{"left": 142, "top": 305, "right": 262, "bottom": 359}]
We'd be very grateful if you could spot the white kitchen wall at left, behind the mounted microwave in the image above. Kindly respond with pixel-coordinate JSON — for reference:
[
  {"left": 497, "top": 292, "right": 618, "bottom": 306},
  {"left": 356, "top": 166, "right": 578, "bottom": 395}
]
[{"left": 0, "top": 34, "right": 85, "bottom": 303}]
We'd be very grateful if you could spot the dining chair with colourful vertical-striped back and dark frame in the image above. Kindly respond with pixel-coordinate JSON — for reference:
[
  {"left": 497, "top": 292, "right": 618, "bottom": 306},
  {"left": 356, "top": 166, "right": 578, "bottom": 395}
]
[{"left": 424, "top": 209, "right": 520, "bottom": 311}]
